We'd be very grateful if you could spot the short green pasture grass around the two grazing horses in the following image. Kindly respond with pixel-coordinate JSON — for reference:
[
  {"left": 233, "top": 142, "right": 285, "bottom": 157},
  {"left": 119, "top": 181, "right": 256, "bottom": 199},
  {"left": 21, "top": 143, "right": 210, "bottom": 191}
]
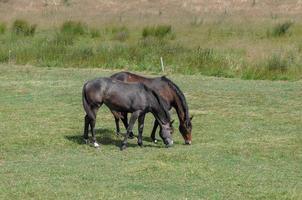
[{"left": 0, "top": 65, "right": 302, "bottom": 199}]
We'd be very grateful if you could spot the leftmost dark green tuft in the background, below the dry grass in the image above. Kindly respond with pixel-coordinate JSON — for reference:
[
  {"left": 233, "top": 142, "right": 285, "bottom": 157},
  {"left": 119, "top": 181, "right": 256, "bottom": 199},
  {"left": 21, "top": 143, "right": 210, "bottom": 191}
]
[{"left": 12, "top": 19, "right": 37, "bottom": 36}]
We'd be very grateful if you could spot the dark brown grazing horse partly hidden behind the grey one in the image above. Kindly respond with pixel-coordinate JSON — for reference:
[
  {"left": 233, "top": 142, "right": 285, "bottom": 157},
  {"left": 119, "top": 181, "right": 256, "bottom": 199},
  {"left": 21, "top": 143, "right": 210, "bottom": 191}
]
[{"left": 111, "top": 72, "right": 193, "bottom": 144}]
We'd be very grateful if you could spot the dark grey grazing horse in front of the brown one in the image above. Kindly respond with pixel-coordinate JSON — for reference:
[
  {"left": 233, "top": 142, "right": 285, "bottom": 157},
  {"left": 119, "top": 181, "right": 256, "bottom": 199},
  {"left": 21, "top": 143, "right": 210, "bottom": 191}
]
[{"left": 82, "top": 78, "right": 173, "bottom": 150}]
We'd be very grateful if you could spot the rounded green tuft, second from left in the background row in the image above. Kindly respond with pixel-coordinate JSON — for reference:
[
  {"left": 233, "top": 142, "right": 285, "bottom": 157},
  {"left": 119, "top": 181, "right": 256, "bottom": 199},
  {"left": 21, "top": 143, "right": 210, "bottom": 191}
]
[{"left": 61, "top": 21, "right": 88, "bottom": 35}]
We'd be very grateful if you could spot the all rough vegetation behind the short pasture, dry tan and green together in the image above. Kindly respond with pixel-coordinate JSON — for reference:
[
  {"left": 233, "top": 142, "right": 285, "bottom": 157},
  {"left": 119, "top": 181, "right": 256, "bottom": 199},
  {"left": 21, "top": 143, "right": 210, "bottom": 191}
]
[{"left": 0, "top": 0, "right": 302, "bottom": 80}]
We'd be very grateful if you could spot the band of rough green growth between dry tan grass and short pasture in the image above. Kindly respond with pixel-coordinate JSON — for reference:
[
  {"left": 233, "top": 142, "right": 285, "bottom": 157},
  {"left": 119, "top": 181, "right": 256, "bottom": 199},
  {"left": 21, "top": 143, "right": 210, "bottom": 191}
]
[{"left": 0, "top": 19, "right": 302, "bottom": 80}]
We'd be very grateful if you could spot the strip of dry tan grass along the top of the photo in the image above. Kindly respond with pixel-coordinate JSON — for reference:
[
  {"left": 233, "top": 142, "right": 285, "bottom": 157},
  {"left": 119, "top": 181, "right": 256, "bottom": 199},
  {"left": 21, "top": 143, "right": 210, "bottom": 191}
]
[{"left": 0, "top": 0, "right": 302, "bottom": 24}]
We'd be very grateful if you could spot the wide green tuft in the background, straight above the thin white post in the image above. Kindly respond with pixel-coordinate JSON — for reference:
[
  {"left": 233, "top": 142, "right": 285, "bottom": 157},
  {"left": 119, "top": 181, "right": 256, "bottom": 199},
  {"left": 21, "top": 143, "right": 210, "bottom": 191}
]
[{"left": 142, "top": 25, "right": 172, "bottom": 38}]
